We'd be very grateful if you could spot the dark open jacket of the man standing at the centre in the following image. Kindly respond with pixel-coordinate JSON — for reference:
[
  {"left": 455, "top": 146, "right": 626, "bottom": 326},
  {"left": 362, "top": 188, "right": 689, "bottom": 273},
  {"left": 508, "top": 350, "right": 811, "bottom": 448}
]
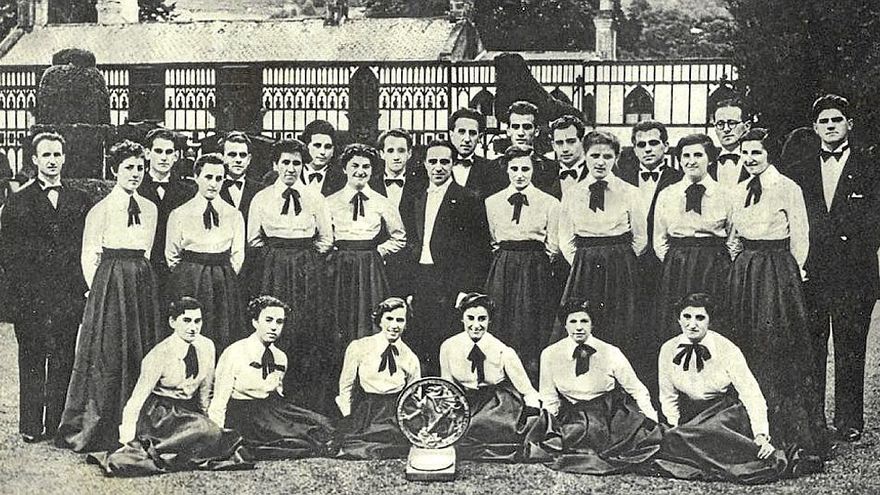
[{"left": 401, "top": 183, "right": 490, "bottom": 291}]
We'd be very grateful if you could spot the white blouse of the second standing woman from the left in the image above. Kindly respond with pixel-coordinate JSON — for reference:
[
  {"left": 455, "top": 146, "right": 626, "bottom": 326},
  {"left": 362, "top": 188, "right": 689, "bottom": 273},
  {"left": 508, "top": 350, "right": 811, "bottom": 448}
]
[{"left": 165, "top": 194, "right": 244, "bottom": 273}]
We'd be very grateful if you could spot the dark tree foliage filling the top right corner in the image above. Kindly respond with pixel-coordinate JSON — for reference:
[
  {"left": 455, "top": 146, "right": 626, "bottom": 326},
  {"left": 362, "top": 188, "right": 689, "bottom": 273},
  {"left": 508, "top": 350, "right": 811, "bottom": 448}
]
[{"left": 728, "top": 0, "right": 880, "bottom": 144}]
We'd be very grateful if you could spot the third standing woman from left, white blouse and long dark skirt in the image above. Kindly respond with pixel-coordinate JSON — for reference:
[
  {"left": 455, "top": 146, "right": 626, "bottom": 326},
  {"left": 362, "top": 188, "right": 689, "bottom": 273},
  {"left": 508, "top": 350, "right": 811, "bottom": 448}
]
[{"left": 247, "top": 139, "right": 340, "bottom": 413}]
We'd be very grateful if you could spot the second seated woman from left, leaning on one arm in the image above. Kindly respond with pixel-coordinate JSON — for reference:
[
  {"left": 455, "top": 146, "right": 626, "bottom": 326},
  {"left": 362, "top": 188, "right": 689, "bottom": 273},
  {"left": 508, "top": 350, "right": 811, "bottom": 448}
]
[{"left": 208, "top": 296, "right": 334, "bottom": 459}]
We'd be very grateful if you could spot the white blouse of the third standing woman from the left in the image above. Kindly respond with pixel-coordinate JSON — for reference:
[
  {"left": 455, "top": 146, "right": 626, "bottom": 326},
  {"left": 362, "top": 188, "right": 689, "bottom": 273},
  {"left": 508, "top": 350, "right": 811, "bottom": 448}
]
[{"left": 247, "top": 179, "right": 333, "bottom": 253}]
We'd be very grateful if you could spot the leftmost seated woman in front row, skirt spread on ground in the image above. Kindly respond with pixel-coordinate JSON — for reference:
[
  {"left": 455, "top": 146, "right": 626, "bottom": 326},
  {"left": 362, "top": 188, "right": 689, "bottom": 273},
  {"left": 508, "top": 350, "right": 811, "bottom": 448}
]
[{"left": 88, "top": 297, "right": 253, "bottom": 476}]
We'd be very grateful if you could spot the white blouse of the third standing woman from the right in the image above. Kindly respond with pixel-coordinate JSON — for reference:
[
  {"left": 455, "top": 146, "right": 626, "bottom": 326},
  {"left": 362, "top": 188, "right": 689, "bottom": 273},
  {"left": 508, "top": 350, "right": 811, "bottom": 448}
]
[{"left": 559, "top": 174, "right": 648, "bottom": 264}]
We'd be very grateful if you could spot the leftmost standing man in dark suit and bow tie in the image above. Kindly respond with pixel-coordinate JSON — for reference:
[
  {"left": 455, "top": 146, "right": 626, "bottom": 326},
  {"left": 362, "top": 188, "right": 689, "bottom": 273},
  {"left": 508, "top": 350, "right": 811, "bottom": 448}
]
[{"left": 0, "top": 133, "right": 92, "bottom": 442}]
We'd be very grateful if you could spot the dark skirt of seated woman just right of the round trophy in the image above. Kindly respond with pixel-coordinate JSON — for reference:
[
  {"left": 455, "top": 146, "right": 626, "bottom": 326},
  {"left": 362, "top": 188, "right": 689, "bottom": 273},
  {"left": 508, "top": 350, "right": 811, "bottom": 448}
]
[{"left": 456, "top": 380, "right": 537, "bottom": 462}]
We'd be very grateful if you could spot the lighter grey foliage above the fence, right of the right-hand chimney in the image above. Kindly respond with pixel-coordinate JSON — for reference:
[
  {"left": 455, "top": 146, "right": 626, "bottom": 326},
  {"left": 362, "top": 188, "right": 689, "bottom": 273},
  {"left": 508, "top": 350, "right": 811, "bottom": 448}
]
[{"left": 618, "top": 0, "right": 735, "bottom": 59}]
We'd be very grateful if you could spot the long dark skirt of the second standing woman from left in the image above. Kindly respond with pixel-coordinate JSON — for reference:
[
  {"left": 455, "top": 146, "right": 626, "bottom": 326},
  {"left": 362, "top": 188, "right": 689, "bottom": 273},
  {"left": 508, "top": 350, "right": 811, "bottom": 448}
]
[{"left": 173, "top": 251, "right": 242, "bottom": 355}]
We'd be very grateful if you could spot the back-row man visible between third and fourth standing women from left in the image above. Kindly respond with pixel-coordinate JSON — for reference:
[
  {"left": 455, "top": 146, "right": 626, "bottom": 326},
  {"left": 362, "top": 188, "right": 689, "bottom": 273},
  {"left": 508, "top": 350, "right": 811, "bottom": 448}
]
[{"left": 300, "top": 120, "right": 345, "bottom": 197}]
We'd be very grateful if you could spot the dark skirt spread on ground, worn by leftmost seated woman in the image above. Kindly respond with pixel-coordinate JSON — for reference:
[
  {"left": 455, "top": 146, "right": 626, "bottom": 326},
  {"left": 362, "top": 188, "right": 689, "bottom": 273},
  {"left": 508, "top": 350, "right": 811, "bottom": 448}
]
[{"left": 87, "top": 395, "right": 254, "bottom": 477}]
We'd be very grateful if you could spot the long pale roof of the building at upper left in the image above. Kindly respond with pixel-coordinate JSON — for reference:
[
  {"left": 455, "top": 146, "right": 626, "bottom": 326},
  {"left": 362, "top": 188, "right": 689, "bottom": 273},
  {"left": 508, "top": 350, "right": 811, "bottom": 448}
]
[{"left": 0, "top": 18, "right": 476, "bottom": 65}]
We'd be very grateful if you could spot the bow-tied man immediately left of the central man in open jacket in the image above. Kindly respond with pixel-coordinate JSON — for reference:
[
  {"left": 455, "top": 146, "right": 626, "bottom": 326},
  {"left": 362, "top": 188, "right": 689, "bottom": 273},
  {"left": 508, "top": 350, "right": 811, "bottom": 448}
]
[{"left": 370, "top": 129, "right": 427, "bottom": 295}]
